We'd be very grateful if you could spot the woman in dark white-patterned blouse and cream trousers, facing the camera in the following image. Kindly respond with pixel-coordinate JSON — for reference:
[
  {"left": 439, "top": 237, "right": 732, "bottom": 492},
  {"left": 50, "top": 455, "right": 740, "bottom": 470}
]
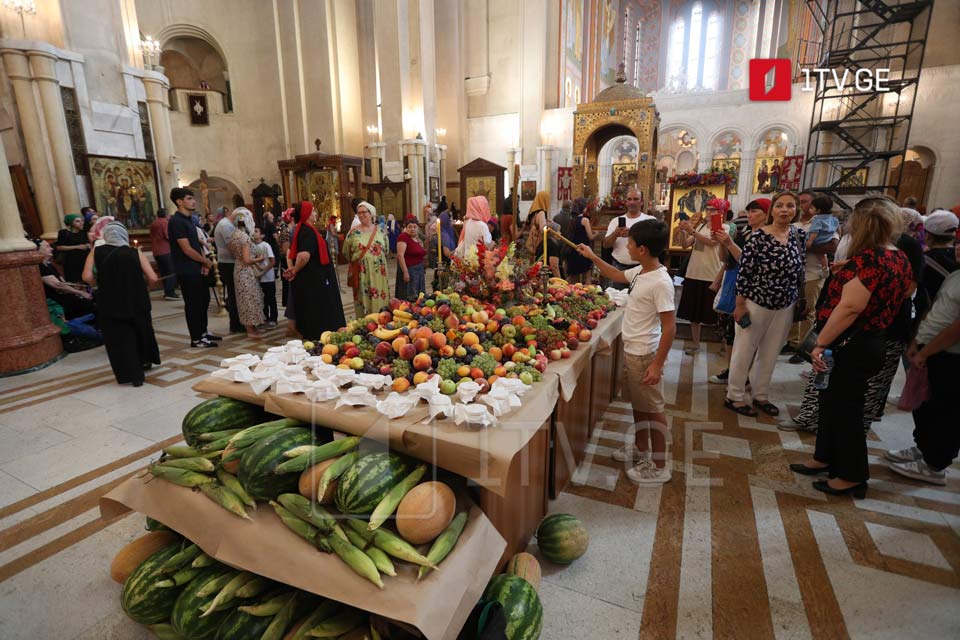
[{"left": 724, "top": 191, "right": 806, "bottom": 416}]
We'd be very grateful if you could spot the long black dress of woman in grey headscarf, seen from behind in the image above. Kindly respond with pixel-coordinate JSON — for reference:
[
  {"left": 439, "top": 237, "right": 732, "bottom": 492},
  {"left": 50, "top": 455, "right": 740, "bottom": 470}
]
[{"left": 93, "top": 245, "right": 160, "bottom": 384}]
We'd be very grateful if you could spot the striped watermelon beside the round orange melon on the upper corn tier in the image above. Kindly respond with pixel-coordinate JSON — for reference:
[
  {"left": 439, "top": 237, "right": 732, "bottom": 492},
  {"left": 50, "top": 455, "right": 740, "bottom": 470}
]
[{"left": 336, "top": 453, "right": 415, "bottom": 515}]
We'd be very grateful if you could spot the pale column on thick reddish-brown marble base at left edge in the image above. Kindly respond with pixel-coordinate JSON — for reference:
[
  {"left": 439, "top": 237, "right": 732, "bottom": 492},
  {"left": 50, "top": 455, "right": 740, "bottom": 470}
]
[{"left": 0, "top": 138, "right": 63, "bottom": 374}]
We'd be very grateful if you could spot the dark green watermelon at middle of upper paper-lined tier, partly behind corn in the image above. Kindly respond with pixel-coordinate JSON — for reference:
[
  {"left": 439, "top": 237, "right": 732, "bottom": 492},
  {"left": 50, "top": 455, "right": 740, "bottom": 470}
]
[{"left": 237, "top": 427, "right": 330, "bottom": 500}]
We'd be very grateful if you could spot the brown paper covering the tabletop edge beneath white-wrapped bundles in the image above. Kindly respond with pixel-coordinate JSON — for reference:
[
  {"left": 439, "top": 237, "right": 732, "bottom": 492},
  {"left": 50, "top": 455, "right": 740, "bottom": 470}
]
[{"left": 193, "top": 376, "right": 560, "bottom": 496}]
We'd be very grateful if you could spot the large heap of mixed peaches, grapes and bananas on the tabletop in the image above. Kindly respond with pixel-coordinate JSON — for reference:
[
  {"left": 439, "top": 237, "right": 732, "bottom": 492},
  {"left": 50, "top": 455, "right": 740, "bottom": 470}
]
[{"left": 304, "top": 278, "right": 614, "bottom": 395}]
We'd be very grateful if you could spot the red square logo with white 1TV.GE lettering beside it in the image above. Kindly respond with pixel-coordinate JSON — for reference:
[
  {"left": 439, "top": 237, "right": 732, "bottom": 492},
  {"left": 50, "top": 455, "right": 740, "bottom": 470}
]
[{"left": 749, "top": 58, "right": 890, "bottom": 101}]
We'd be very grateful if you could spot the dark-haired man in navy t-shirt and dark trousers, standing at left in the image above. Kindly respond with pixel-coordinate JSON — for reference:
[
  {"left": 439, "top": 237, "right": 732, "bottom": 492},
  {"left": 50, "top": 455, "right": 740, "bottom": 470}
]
[{"left": 167, "top": 187, "right": 220, "bottom": 349}]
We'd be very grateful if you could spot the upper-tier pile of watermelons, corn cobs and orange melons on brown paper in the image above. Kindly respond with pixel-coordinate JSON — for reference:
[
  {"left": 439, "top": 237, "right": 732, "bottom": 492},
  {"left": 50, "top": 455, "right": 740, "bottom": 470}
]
[{"left": 149, "top": 397, "right": 467, "bottom": 589}]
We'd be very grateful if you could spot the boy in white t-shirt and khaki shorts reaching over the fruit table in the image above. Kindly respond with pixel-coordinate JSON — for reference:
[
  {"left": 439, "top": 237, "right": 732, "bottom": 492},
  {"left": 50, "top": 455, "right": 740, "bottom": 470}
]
[{"left": 577, "top": 220, "right": 677, "bottom": 483}]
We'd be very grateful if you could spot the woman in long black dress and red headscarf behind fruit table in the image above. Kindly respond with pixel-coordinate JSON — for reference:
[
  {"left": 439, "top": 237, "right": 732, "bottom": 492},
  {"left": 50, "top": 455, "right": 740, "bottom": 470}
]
[{"left": 283, "top": 202, "right": 347, "bottom": 340}]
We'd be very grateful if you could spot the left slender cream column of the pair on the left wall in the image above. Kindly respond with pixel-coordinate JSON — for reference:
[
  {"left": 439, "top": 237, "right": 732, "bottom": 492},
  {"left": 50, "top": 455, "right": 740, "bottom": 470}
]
[{"left": 0, "top": 49, "right": 61, "bottom": 240}]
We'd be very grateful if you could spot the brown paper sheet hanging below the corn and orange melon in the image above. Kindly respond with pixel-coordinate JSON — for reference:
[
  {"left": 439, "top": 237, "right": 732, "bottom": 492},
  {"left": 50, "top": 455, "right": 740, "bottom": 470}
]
[{"left": 100, "top": 478, "right": 506, "bottom": 640}]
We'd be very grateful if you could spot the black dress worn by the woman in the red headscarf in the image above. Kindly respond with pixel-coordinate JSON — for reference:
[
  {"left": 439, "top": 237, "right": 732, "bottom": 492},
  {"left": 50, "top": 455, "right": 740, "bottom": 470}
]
[{"left": 291, "top": 225, "right": 347, "bottom": 340}]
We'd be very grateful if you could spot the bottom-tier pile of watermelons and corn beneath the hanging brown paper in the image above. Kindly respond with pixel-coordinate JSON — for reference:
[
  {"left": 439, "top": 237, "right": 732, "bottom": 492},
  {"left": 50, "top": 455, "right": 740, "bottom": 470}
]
[{"left": 110, "top": 519, "right": 419, "bottom": 640}]
